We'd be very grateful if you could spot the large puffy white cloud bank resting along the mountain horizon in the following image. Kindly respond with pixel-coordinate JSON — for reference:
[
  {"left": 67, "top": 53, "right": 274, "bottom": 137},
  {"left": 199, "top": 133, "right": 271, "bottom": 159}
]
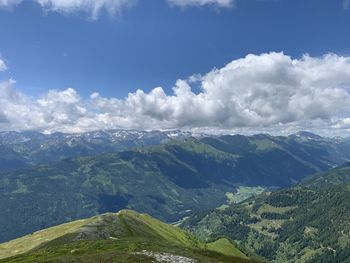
[{"left": 0, "top": 53, "right": 350, "bottom": 135}]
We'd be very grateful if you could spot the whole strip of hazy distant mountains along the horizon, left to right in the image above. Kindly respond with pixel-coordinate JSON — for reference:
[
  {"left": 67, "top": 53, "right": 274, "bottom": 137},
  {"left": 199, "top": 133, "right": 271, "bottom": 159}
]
[{"left": 0, "top": 130, "right": 350, "bottom": 171}]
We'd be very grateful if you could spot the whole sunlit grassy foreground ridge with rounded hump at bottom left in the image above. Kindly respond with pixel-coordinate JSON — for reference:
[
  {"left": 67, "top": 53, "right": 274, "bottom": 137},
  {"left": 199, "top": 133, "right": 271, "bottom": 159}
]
[{"left": 0, "top": 210, "right": 252, "bottom": 262}]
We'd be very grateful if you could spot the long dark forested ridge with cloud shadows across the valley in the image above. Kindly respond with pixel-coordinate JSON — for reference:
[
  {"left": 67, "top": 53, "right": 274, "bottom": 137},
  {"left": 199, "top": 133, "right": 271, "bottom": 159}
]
[{"left": 0, "top": 135, "right": 348, "bottom": 242}]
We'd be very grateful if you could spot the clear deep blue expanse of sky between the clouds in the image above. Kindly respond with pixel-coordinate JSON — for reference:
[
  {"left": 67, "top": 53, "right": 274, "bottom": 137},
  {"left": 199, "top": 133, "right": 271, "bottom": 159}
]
[{"left": 0, "top": 0, "right": 350, "bottom": 97}]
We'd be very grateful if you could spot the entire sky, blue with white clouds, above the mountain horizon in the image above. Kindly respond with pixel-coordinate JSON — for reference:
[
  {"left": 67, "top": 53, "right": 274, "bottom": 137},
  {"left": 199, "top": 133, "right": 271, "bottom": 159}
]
[{"left": 0, "top": 0, "right": 350, "bottom": 136}]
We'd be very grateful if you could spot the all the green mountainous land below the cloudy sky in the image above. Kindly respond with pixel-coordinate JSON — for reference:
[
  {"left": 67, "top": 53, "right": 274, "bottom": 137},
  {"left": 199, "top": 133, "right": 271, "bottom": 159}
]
[{"left": 0, "top": 130, "right": 350, "bottom": 263}]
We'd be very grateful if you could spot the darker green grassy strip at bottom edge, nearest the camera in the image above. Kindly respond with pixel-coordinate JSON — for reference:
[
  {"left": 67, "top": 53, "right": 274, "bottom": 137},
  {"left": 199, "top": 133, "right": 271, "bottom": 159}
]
[{"left": 0, "top": 238, "right": 258, "bottom": 263}]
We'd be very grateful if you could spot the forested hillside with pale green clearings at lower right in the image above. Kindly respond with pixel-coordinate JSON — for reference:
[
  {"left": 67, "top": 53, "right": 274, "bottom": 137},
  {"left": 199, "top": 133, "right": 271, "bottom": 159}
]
[{"left": 182, "top": 165, "right": 350, "bottom": 263}]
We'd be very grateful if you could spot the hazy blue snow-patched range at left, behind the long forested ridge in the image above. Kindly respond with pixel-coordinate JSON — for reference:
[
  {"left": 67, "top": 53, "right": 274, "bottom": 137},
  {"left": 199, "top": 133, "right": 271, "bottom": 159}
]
[{"left": 0, "top": 130, "right": 192, "bottom": 171}]
